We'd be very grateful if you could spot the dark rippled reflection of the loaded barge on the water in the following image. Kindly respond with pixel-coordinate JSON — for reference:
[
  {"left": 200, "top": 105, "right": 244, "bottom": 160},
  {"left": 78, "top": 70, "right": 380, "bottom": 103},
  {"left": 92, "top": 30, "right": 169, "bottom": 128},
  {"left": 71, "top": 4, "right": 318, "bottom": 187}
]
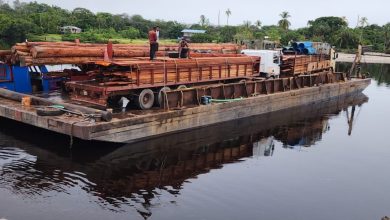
[{"left": 0, "top": 93, "right": 368, "bottom": 218}]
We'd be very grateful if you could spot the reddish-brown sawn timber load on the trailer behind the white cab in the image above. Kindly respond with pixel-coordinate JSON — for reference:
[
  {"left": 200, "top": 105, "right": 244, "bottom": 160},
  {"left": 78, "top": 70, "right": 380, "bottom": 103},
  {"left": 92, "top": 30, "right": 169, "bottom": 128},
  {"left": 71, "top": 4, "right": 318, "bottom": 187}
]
[{"left": 90, "top": 56, "right": 260, "bottom": 86}]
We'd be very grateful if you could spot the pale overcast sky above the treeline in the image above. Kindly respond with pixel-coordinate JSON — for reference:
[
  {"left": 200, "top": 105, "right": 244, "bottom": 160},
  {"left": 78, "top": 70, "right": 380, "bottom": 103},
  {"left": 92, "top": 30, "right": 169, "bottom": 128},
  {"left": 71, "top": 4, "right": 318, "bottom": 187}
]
[{"left": 18, "top": 0, "right": 390, "bottom": 28}]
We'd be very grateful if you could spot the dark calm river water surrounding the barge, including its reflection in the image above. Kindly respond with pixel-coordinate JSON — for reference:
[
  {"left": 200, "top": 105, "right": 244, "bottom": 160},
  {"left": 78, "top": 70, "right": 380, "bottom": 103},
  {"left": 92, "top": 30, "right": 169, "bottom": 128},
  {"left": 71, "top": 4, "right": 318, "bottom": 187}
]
[{"left": 0, "top": 62, "right": 390, "bottom": 220}]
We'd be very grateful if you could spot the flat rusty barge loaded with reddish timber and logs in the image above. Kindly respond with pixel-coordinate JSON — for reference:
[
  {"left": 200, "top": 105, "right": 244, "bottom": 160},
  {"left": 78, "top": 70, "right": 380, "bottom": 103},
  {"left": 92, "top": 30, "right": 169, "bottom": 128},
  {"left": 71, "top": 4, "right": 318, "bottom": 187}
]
[{"left": 0, "top": 43, "right": 371, "bottom": 143}]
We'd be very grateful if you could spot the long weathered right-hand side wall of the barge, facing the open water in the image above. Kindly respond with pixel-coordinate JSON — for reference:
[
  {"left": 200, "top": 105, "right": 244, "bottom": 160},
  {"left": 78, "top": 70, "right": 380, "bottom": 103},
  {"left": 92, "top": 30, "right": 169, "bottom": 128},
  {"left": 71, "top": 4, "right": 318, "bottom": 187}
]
[{"left": 90, "top": 79, "right": 371, "bottom": 143}]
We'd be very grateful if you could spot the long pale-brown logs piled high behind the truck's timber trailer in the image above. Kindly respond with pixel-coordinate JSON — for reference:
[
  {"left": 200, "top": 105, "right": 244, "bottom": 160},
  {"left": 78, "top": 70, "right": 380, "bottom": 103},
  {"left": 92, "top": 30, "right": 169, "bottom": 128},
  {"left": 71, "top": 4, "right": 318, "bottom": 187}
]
[{"left": 0, "top": 42, "right": 241, "bottom": 66}]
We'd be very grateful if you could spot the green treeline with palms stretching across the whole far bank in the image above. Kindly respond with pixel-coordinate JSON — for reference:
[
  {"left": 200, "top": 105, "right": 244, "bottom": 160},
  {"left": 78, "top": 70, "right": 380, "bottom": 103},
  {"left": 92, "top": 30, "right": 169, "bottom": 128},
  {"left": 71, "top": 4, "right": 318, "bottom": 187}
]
[{"left": 0, "top": 0, "right": 390, "bottom": 52}]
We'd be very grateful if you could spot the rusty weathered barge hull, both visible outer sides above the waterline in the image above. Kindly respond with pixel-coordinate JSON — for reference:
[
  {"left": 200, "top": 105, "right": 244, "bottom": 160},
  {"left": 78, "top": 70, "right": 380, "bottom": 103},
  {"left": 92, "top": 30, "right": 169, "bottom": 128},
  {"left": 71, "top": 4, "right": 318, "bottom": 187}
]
[{"left": 0, "top": 79, "right": 371, "bottom": 143}]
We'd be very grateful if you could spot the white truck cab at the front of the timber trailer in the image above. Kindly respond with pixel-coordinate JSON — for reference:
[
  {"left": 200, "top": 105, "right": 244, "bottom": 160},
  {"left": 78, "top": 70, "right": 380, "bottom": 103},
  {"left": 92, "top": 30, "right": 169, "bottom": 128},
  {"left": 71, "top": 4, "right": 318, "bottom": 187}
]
[{"left": 241, "top": 50, "right": 281, "bottom": 78}]
